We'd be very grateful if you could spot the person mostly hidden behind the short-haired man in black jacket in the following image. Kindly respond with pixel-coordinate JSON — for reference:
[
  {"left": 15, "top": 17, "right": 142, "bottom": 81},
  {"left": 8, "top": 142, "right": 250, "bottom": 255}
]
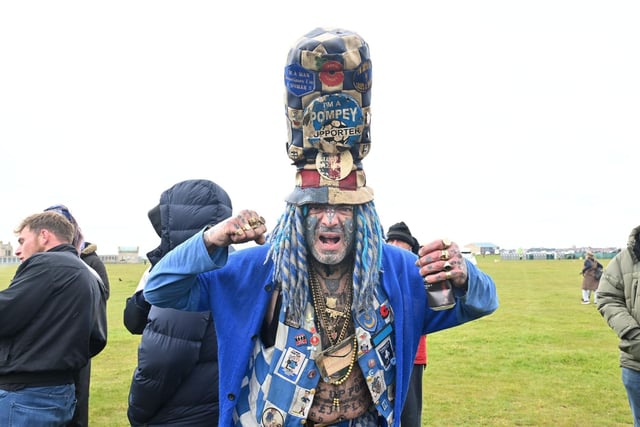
[{"left": 45, "top": 205, "right": 111, "bottom": 427}]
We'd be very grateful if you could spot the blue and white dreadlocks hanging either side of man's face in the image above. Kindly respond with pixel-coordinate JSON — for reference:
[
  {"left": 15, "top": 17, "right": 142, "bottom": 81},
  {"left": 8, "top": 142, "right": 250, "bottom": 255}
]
[{"left": 267, "top": 201, "right": 384, "bottom": 322}]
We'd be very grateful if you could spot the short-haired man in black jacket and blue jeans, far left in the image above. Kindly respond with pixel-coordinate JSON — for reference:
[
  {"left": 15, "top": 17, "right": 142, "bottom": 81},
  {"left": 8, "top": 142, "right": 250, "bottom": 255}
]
[{"left": 0, "top": 212, "right": 106, "bottom": 426}]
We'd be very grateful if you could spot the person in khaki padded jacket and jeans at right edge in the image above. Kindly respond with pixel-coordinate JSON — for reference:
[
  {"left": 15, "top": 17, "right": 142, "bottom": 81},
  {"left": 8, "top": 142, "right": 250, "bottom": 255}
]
[{"left": 597, "top": 226, "right": 640, "bottom": 427}]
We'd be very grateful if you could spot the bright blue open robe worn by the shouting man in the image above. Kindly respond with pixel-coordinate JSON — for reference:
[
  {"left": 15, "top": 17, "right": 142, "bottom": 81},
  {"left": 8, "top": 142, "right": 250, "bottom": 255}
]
[{"left": 144, "top": 232, "right": 498, "bottom": 426}]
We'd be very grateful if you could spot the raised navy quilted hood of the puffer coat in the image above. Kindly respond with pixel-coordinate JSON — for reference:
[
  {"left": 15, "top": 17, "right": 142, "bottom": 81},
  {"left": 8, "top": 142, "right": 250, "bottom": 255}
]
[{"left": 147, "top": 179, "right": 233, "bottom": 266}]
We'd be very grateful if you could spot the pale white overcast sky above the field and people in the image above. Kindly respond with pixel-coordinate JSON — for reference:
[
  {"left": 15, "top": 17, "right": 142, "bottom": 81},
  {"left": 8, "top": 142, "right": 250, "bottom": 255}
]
[{"left": 0, "top": 0, "right": 640, "bottom": 255}]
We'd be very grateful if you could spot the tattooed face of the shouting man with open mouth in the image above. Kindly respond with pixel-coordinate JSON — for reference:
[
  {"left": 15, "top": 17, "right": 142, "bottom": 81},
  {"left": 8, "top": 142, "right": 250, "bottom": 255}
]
[{"left": 304, "top": 204, "right": 355, "bottom": 265}]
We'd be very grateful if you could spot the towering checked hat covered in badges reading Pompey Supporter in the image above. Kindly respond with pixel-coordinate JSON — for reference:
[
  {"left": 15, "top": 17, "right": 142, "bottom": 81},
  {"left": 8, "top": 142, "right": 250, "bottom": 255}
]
[{"left": 284, "top": 28, "right": 373, "bottom": 205}]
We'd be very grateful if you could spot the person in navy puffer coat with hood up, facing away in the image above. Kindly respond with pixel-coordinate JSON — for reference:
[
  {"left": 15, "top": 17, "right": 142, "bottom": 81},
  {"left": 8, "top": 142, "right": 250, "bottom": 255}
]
[{"left": 123, "top": 179, "right": 232, "bottom": 427}]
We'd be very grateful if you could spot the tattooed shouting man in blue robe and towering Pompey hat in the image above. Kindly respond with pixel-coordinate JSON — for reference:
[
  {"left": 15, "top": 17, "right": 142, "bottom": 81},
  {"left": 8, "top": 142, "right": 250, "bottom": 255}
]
[{"left": 144, "top": 28, "right": 498, "bottom": 426}]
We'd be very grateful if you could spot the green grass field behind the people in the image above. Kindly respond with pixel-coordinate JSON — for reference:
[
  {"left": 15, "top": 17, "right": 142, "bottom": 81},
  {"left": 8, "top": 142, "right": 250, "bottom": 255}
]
[{"left": 0, "top": 256, "right": 633, "bottom": 427}]
